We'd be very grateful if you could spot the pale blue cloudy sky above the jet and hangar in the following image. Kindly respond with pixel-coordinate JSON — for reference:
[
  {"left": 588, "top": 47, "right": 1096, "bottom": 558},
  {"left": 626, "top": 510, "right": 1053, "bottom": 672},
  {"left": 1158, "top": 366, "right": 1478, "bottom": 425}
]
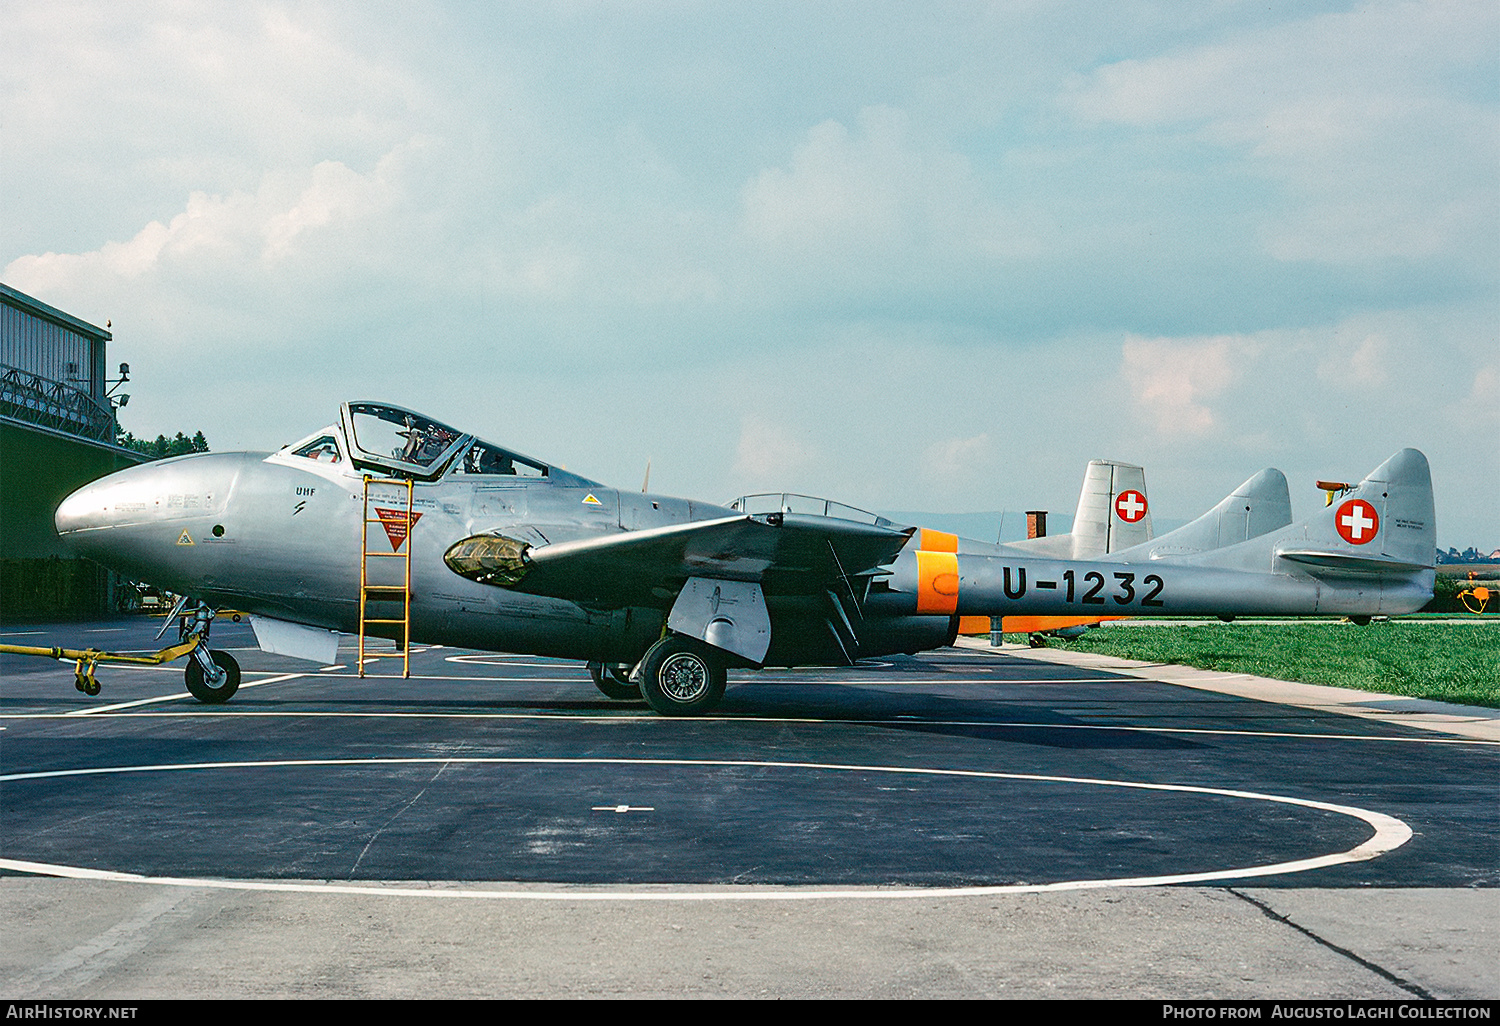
[{"left": 0, "top": 0, "right": 1500, "bottom": 551}]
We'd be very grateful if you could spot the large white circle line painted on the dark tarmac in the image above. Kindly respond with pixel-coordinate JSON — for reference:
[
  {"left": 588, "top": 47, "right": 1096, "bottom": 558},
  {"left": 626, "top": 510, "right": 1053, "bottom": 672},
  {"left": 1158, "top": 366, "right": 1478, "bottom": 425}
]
[{"left": 0, "top": 756, "right": 1412, "bottom": 902}]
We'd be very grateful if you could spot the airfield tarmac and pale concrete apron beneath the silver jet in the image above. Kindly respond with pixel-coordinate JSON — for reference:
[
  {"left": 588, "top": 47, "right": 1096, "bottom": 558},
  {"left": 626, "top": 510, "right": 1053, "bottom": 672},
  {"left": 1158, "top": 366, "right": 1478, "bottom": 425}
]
[{"left": 0, "top": 618, "right": 1500, "bottom": 999}]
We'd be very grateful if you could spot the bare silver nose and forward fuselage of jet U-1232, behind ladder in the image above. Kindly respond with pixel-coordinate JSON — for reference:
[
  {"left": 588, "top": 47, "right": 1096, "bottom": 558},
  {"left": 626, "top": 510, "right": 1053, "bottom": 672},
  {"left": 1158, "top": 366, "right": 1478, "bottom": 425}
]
[{"left": 56, "top": 453, "right": 714, "bottom": 662}]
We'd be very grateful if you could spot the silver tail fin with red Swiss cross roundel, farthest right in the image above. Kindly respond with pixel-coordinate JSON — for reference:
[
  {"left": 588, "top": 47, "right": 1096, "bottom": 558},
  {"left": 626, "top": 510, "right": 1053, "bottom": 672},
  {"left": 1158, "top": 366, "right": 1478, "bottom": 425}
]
[{"left": 1275, "top": 449, "right": 1437, "bottom": 573}]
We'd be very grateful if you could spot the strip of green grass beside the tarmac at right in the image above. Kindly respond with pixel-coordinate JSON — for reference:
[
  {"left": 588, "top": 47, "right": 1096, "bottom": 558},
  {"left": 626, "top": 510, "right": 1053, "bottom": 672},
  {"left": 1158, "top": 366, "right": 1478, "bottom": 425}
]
[{"left": 1047, "top": 621, "right": 1500, "bottom": 708}]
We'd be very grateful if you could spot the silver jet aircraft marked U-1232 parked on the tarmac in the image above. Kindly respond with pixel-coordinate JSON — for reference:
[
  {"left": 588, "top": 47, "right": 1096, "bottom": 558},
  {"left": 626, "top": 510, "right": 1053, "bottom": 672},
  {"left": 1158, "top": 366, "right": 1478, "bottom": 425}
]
[{"left": 56, "top": 402, "right": 1436, "bottom": 716}]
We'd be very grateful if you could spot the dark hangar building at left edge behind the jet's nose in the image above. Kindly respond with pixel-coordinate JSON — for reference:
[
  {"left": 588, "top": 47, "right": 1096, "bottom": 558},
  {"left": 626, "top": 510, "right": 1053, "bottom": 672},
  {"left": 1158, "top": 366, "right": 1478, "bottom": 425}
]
[{"left": 0, "top": 285, "right": 146, "bottom": 623}]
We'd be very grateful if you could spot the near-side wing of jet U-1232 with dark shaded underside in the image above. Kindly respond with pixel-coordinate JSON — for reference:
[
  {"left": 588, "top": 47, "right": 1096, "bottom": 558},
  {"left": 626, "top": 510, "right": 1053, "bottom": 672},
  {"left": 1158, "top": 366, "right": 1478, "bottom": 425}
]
[{"left": 444, "top": 513, "right": 912, "bottom": 606}]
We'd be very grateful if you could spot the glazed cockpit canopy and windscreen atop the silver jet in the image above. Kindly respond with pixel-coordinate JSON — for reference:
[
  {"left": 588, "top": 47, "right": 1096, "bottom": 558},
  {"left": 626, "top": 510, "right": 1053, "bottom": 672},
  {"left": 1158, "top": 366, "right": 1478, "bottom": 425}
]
[{"left": 282, "top": 402, "right": 582, "bottom": 482}]
